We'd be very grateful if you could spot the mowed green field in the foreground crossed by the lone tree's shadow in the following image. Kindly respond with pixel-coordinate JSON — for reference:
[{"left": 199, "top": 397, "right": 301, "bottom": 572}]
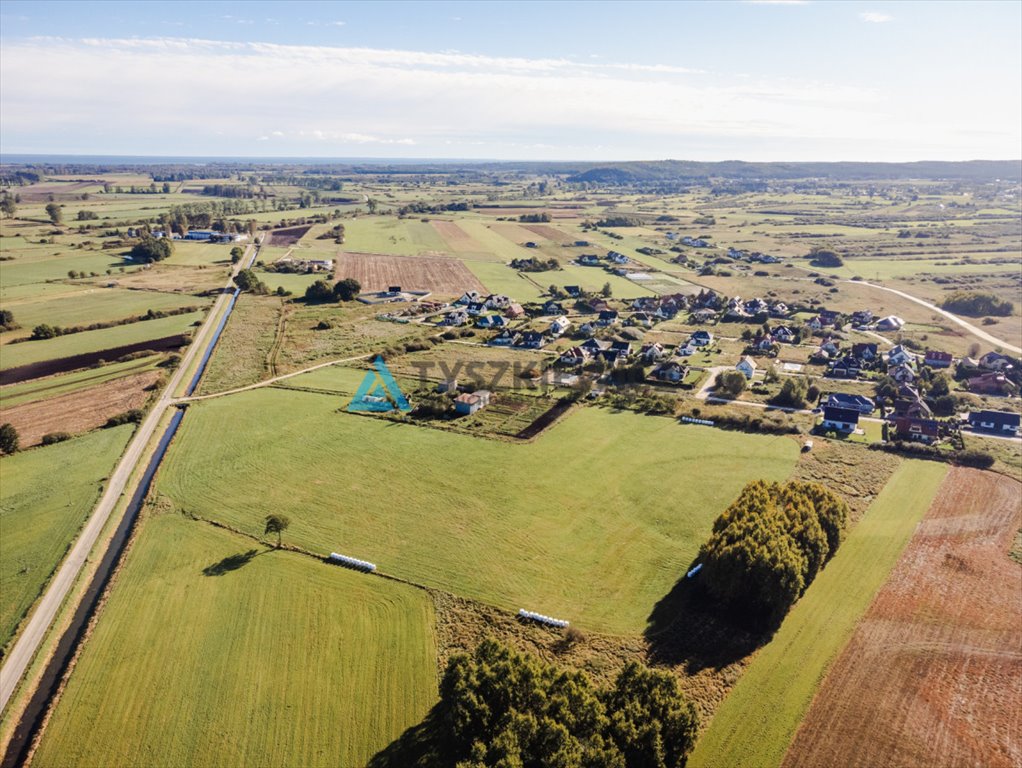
[{"left": 33, "top": 513, "right": 436, "bottom": 768}]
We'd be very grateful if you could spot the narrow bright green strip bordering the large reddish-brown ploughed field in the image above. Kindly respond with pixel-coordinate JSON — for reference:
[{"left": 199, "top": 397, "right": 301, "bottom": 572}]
[{"left": 689, "top": 460, "right": 947, "bottom": 768}]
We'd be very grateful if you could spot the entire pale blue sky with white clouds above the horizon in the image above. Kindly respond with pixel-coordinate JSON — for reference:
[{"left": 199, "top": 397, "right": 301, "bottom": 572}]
[{"left": 0, "top": 0, "right": 1022, "bottom": 162}]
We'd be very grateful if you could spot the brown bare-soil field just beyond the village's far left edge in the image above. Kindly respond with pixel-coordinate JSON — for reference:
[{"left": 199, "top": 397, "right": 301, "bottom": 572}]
[{"left": 336, "top": 253, "right": 485, "bottom": 295}]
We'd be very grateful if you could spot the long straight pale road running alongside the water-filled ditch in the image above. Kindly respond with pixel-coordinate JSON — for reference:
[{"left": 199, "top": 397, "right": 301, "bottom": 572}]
[{"left": 0, "top": 244, "right": 258, "bottom": 712}]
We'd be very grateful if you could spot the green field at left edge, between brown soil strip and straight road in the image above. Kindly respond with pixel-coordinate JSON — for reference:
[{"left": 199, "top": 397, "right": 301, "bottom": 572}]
[{"left": 0, "top": 424, "right": 134, "bottom": 648}]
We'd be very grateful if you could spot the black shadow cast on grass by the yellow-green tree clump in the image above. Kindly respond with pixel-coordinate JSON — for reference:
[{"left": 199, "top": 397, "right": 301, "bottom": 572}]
[{"left": 644, "top": 562, "right": 772, "bottom": 675}]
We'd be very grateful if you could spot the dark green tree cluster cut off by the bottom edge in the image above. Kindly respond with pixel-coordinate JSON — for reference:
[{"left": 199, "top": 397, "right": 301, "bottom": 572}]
[{"left": 424, "top": 640, "right": 697, "bottom": 768}]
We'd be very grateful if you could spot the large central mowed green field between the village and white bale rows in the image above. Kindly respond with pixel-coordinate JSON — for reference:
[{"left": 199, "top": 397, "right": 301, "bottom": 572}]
[{"left": 158, "top": 389, "right": 798, "bottom": 633}]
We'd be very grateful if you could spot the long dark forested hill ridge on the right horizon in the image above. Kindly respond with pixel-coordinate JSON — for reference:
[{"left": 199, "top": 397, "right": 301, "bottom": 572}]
[{"left": 567, "top": 160, "right": 1022, "bottom": 184}]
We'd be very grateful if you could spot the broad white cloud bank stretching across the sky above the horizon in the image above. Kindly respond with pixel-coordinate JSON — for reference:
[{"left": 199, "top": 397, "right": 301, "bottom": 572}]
[{"left": 0, "top": 38, "right": 1019, "bottom": 160}]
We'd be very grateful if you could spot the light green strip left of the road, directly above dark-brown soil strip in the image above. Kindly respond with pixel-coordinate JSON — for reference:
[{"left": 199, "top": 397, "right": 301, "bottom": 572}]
[{"left": 0, "top": 311, "right": 205, "bottom": 369}]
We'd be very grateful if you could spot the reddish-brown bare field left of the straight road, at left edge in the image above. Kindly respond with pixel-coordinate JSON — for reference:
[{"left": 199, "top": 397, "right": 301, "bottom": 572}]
[{"left": 0, "top": 371, "right": 160, "bottom": 448}]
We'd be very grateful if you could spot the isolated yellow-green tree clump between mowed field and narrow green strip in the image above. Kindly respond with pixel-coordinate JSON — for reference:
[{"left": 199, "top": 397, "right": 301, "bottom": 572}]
[{"left": 699, "top": 481, "right": 848, "bottom": 623}]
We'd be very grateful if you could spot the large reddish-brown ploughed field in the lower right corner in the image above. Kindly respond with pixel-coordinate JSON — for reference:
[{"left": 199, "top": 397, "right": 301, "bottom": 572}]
[{"left": 783, "top": 467, "right": 1022, "bottom": 768}]
